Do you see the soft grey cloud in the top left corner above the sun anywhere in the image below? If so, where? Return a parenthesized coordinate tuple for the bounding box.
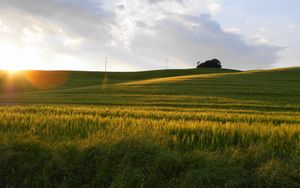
(0, 0, 114, 40)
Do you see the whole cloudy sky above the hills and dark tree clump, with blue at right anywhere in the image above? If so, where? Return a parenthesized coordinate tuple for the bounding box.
(0, 0, 300, 71)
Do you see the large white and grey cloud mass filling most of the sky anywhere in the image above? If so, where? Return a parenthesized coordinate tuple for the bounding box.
(0, 0, 281, 70)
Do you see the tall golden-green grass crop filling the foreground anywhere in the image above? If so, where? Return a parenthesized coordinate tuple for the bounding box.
(0, 105, 300, 187)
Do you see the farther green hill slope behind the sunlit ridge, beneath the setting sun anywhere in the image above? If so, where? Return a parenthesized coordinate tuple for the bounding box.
(0, 68, 238, 92)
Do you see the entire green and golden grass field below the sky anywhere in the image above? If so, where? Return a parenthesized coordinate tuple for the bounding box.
(0, 67, 300, 188)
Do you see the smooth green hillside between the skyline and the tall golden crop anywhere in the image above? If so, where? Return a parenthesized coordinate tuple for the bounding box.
(0, 67, 300, 105)
